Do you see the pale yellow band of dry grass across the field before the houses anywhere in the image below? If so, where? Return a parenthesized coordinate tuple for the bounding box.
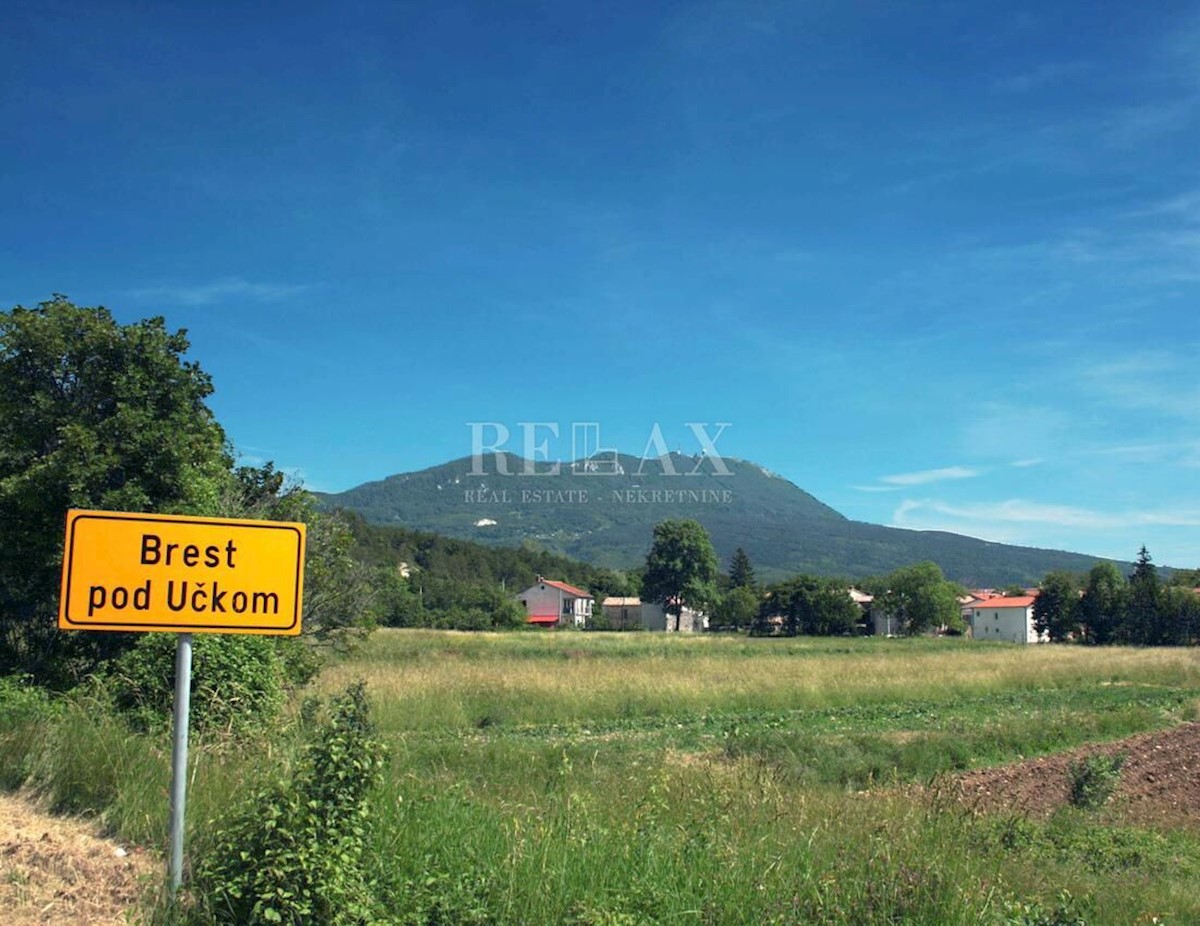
(322, 630, 1200, 730)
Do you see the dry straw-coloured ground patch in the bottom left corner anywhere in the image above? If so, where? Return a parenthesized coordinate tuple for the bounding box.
(0, 794, 161, 926)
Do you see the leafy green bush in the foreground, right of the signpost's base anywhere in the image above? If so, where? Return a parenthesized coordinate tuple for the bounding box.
(192, 683, 384, 926)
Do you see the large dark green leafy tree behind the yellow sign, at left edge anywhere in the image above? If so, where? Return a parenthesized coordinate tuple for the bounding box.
(0, 296, 232, 685)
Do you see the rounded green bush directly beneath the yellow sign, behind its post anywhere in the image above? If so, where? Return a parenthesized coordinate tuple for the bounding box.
(112, 633, 290, 732)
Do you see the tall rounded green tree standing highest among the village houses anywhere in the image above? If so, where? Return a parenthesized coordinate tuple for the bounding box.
(642, 519, 718, 631)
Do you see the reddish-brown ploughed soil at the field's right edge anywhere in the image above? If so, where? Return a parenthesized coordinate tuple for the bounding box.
(955, 723, 1200, 829)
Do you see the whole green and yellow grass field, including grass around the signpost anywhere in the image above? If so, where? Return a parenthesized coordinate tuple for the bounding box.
(7, 631, 1200, 926)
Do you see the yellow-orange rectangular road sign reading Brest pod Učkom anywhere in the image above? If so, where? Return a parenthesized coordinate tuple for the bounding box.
(59, 510, 305, 635)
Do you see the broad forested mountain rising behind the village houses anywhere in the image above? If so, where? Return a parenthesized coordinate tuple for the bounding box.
(320, 453, 1123, 587)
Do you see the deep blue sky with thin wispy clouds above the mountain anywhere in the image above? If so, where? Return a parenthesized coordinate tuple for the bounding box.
(0, 0, 1200, 566)
